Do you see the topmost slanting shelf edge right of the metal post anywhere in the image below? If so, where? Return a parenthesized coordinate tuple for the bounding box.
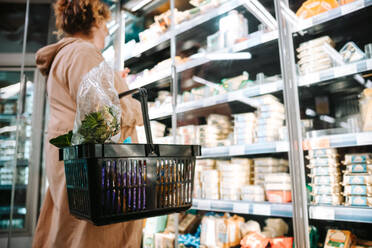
(295, 0, 372, 32)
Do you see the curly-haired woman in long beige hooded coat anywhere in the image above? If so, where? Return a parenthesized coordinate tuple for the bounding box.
(33, 0, 142, 248)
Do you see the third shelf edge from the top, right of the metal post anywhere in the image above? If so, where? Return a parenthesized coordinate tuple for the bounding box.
(303, 132, 372, 150)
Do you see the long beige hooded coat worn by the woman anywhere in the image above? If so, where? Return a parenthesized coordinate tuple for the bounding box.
(32, 38, 142, 248)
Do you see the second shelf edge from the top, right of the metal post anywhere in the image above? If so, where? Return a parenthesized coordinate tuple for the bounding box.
(299, 59, 372, 86)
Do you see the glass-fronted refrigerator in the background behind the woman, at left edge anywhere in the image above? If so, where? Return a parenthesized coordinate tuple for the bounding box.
(0, 68, 45, 235)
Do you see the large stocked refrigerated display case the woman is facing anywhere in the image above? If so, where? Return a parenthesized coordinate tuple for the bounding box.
(124, 0, 372, 247)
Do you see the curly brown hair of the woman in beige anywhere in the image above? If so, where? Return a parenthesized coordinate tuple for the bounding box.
(54, 0, 111, 36)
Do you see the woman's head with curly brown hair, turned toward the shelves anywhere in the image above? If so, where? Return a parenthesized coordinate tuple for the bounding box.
(54, 0, 110, 49)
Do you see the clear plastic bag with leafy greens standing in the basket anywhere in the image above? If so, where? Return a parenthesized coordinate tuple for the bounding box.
(72, 61, 121, 145)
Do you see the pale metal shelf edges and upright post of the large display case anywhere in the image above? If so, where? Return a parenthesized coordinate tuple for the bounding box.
(123, 0, 372, 247)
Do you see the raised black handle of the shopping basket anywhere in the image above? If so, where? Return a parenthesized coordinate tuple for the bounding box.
(119, 88, 155, 152)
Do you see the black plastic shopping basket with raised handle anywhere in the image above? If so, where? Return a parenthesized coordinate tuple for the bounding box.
(60, 88, 201, 225)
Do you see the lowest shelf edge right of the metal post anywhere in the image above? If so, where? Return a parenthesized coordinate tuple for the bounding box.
(309, 206, 372, 223)
